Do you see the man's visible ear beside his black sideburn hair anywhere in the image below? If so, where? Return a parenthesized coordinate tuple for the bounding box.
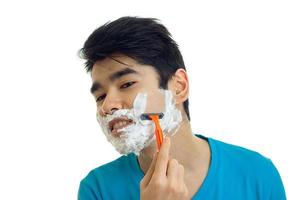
(168, 68, 189, 104)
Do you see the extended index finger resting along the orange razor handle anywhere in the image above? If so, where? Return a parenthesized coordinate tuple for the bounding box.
(153, 137, 171, 177)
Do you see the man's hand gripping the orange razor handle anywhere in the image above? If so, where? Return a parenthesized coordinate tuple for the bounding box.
(140, 137, 188, 200)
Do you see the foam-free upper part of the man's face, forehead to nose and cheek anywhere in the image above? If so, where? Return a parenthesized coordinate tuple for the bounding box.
(91, 55, 163, 116)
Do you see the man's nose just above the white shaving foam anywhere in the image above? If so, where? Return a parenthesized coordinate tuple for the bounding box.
(100, 92, 122, 116)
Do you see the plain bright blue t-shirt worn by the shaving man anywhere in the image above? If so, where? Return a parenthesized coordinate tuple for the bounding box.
(78, 135, 286, 200)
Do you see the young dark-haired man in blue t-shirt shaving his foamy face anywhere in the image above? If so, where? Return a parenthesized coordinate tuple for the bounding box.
(78, 17, 286, 200)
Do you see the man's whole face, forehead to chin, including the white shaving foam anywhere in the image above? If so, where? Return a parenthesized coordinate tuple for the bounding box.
(91, 55, 181, 154)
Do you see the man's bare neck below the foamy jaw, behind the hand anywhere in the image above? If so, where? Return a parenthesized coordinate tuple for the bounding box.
(138, 119, 210, 173)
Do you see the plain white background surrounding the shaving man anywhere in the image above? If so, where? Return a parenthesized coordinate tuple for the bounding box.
(0, 0, 300, 200)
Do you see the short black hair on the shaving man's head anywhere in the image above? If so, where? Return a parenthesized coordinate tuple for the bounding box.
(79, 17, 190, 120)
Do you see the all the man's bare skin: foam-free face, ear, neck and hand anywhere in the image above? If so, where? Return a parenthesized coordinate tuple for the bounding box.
(91, 54, 210, 200)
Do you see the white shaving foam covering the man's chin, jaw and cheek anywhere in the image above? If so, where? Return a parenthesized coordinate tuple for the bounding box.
(97, 90, 182, 155)
